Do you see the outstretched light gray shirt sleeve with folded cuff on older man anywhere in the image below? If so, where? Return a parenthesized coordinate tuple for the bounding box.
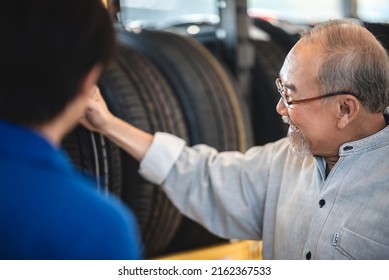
(140, 133, 278, 240)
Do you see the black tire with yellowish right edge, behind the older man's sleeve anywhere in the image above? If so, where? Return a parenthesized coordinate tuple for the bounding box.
(115, 27, 252, 253)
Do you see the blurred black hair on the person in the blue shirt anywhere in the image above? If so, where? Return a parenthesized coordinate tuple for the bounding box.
(0, 0, 114, 126)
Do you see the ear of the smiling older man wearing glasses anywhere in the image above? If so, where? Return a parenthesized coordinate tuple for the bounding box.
(337, 95, 360, 129)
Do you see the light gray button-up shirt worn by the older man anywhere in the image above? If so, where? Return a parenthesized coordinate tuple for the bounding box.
(140, 123, 389, 259)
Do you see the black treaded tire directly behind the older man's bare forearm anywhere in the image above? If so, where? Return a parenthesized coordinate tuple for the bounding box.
(100, 45, 188, 257)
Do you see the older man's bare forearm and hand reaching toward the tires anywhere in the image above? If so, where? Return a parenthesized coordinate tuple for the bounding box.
(80, 86, 153, 161)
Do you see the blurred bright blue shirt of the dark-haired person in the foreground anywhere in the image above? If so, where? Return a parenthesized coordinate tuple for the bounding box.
(0, 121, 141, 260)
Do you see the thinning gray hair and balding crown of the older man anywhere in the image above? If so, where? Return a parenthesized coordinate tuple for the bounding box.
(301, 20, 389, 113)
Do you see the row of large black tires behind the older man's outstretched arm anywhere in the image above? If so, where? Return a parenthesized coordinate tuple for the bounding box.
(63, 24, 253, 258)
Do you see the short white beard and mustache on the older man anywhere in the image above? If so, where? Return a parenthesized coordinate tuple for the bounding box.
(282, 116, 312, 157)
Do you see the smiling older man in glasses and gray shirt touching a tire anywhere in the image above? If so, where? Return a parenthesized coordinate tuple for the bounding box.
(83, 20, 389, 259)
